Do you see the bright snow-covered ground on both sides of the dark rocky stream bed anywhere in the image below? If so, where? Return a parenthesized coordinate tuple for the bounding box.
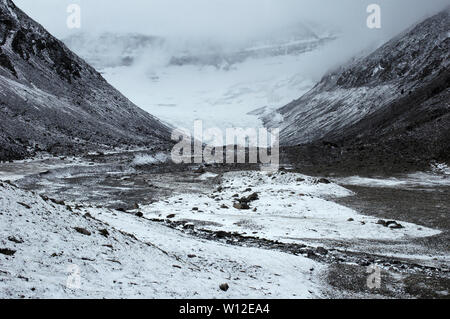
(0, 171, 439, 298)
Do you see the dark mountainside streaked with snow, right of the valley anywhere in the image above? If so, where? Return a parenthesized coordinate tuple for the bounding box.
(265, 9, 450, 159)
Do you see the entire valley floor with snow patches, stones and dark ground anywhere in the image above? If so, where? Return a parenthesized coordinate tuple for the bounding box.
(0, 152, 450, 298)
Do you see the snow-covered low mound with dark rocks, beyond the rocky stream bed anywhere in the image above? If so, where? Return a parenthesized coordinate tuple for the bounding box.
(142, 171, 440, 243)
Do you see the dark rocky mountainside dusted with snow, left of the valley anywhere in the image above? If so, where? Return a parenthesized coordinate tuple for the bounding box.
(0, 0, 169, 160)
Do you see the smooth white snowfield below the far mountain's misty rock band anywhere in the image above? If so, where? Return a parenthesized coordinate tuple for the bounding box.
(102, 55, 314, 131)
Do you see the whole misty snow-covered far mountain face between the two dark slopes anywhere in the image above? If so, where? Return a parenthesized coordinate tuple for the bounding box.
(63, 25, 334, 130)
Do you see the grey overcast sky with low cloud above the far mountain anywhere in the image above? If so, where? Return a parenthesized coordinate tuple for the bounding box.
(13, 0, 450, 38)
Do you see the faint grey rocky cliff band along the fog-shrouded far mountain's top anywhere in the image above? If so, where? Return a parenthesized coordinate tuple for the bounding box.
(62, 23, 330, 71)
